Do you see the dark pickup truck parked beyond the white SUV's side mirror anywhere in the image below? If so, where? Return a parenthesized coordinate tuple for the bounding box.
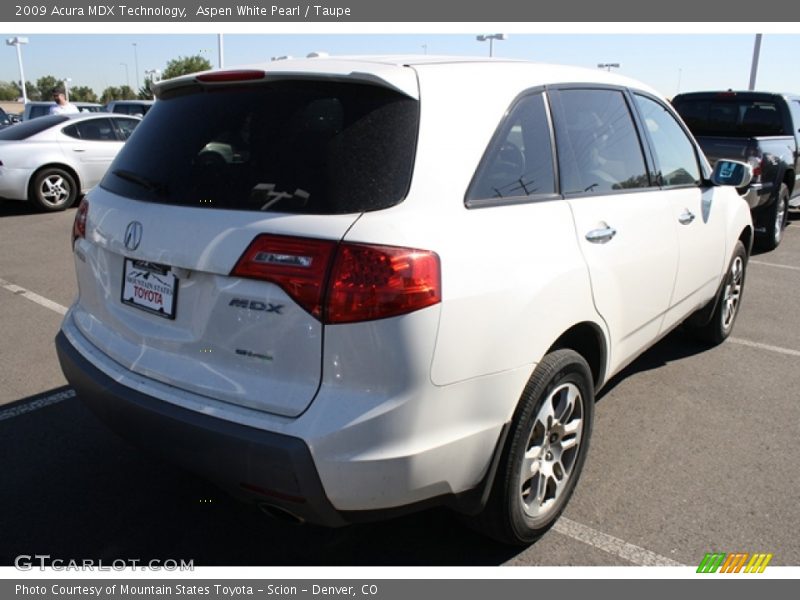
(672, 91, 800, 250)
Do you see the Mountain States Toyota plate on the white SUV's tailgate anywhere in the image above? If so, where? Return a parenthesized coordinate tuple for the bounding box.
(122, 258, 178, 319)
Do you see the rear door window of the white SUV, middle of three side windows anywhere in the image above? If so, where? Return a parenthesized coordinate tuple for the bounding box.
(557, 90, 650, 193)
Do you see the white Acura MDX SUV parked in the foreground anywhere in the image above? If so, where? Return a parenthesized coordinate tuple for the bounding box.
(56, 57, 753, 544)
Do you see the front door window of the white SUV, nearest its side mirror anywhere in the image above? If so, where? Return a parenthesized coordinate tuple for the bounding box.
(634, 94, 700, 187)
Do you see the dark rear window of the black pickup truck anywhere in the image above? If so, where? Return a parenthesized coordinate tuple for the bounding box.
(675, 97, 788, 137)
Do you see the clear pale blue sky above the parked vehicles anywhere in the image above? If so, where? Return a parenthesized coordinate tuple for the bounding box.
(0, 30, 800, 97)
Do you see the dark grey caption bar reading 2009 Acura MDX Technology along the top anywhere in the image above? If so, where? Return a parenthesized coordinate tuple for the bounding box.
(0, 0, 800, 25)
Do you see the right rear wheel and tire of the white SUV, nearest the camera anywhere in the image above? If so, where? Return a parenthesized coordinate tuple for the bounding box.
(475, 350, 594, 546)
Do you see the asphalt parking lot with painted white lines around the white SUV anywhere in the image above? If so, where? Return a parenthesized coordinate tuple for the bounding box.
(0, 202, 800, 566)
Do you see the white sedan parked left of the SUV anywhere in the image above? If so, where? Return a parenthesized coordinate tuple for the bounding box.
(0, 113, 141, 211)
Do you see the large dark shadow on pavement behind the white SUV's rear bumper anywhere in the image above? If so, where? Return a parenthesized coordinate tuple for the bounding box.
(0, 388, 519, 566)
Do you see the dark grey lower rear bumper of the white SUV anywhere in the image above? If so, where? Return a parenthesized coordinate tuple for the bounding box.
(55, 332, 348, 527)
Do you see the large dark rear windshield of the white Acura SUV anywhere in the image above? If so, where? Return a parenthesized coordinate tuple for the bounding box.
(101, 81, 419, 214)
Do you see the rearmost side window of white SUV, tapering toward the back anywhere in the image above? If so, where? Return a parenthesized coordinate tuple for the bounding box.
(467, 94, 556, 201)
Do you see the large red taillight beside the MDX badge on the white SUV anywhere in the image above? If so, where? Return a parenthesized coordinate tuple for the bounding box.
(231, 235, 441, 324)
